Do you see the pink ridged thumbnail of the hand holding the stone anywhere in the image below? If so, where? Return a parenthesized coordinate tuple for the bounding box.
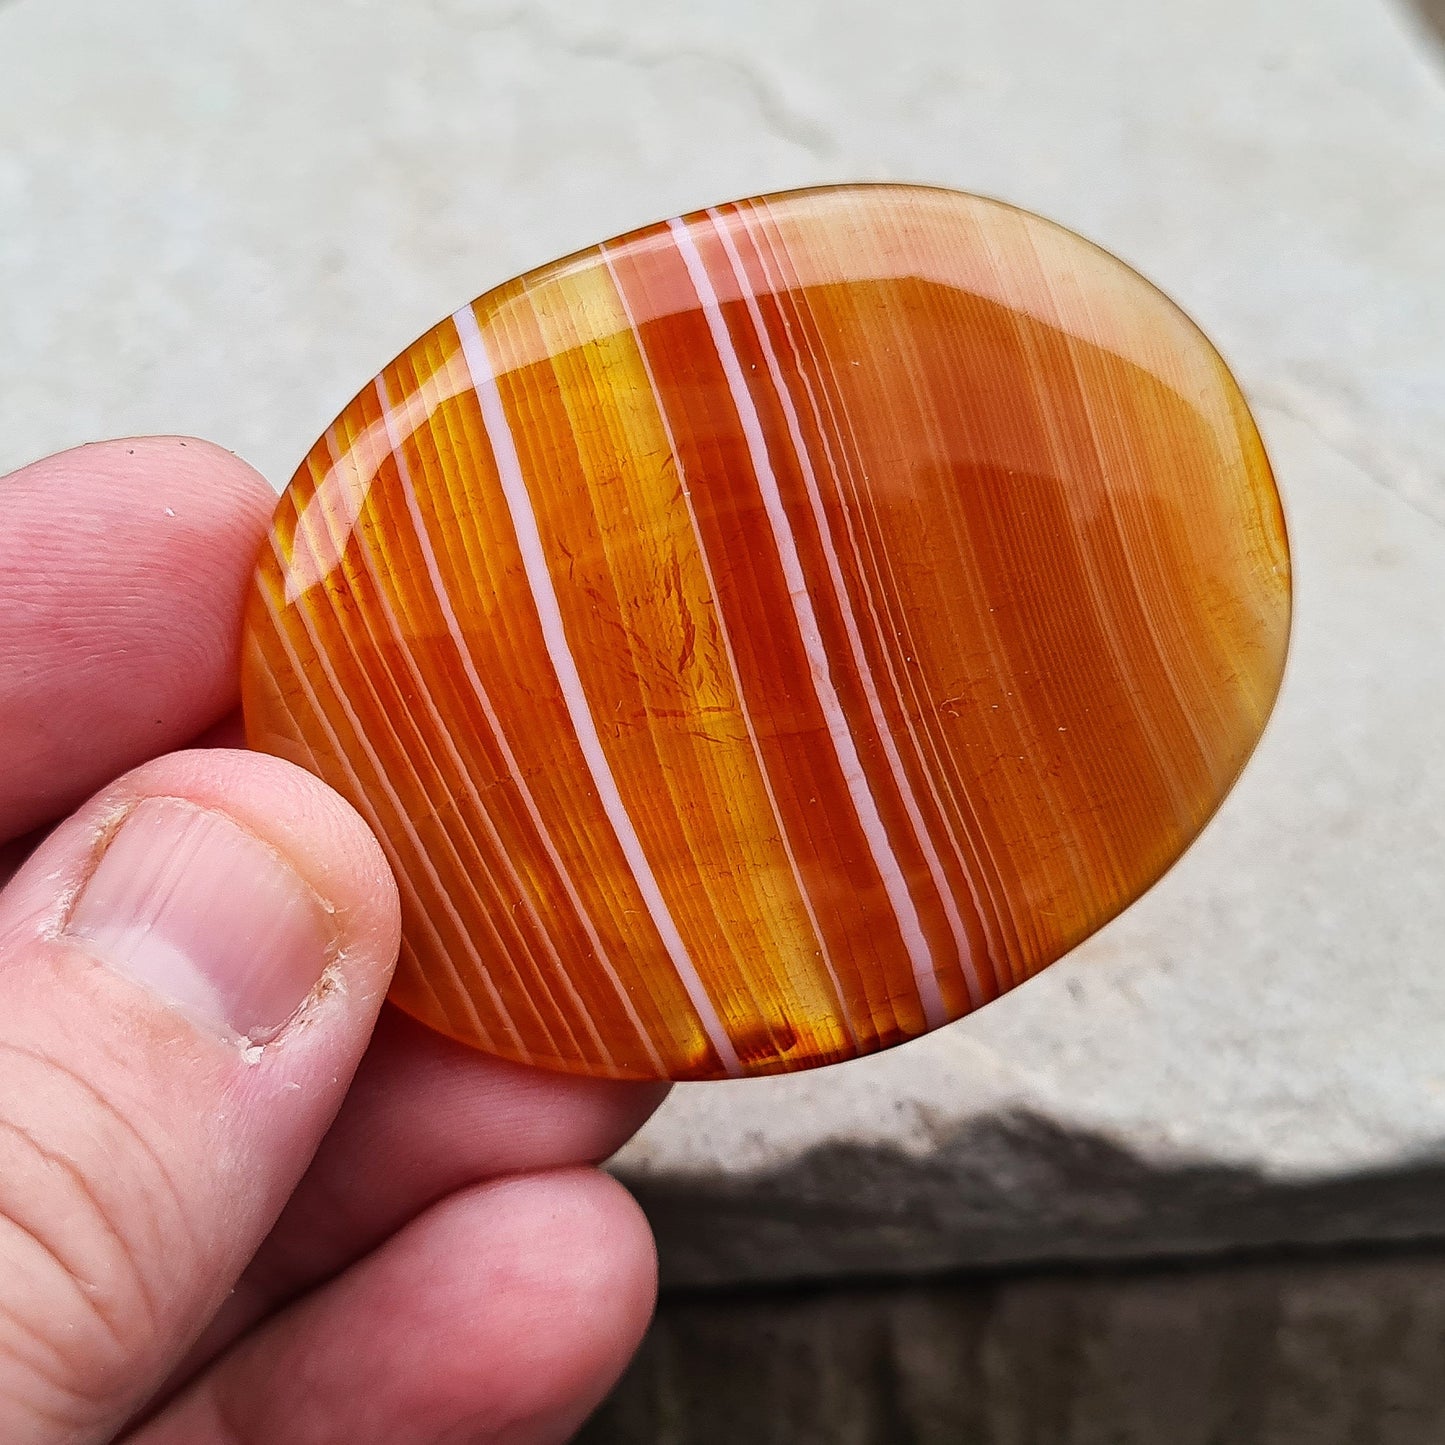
(65, 798, 335, 1040)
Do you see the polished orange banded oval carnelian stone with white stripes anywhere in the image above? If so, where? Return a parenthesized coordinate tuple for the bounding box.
(244, 185, 1289, 1079)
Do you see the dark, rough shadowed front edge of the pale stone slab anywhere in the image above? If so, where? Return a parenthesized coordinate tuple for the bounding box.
(624, 1113, 1445, 1287)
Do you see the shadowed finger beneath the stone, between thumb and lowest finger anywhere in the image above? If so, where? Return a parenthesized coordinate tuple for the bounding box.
(183, 1009, 666, 1364)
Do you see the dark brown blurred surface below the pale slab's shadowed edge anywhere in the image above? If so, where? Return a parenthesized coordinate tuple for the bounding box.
(579, 1248, 1445, 1445)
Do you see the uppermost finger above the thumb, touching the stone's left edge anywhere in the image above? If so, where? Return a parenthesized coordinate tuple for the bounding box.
(0, 436, 276, 841)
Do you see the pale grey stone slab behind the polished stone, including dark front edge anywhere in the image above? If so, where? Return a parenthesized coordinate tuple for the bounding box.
(0, 0, 1445, 1282)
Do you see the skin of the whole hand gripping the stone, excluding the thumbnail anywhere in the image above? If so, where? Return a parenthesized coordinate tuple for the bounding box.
(0, 438, 663, 1445)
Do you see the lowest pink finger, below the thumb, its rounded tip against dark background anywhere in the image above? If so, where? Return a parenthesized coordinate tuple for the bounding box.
(133, 1170, 656, 1445)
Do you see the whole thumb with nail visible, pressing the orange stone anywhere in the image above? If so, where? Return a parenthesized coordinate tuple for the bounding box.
(0, 750, 399, 1445)
